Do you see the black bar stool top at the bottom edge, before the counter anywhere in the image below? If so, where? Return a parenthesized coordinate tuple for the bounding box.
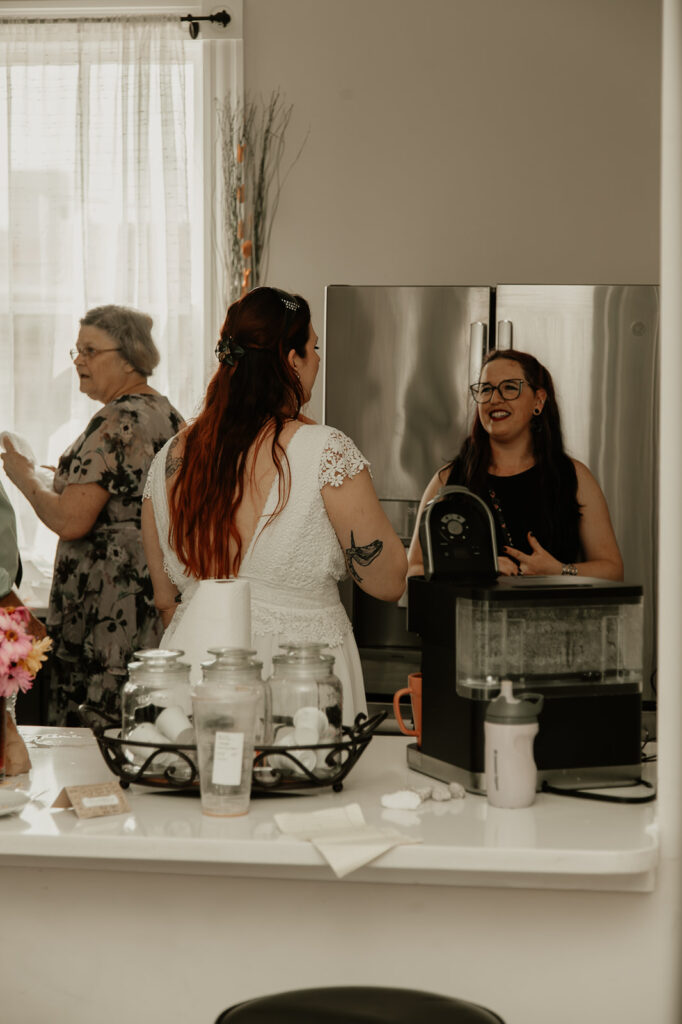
(215, 985, 504, 1024)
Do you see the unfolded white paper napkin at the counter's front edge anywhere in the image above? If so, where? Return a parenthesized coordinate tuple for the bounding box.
(274, 804, 421, 879)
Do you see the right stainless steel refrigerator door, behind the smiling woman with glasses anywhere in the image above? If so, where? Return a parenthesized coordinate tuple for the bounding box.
(496, 285, 659, 696)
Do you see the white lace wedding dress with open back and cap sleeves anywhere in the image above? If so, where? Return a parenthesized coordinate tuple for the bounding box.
(144, 424, 369, 725)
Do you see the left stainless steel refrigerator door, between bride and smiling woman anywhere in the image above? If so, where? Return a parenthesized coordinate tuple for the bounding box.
(325, 285, 491, 503)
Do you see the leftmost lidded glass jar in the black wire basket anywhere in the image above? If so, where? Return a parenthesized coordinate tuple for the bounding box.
(121, 648, 195, 770)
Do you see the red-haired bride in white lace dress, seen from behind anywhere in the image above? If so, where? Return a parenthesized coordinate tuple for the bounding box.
(142, 288, 407, 724)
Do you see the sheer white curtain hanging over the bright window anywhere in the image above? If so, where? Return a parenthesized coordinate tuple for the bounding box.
(0, 16, 205, 581)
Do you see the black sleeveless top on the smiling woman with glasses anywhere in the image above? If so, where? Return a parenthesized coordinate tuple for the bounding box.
(447, 459, 580, 562)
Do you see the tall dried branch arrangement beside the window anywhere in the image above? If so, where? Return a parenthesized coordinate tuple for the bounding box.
(216, 89, 307, 302)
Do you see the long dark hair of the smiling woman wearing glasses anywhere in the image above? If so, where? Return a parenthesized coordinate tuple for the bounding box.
(451, 348, 581, 558)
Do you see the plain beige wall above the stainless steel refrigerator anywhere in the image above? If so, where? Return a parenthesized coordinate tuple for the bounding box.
(244, 0, 660, 415)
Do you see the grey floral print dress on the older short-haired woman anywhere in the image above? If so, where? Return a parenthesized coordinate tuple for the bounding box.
(47, 394, 183, 725)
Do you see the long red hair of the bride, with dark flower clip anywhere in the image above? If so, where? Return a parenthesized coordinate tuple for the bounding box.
(169, 288, 310, 580)
